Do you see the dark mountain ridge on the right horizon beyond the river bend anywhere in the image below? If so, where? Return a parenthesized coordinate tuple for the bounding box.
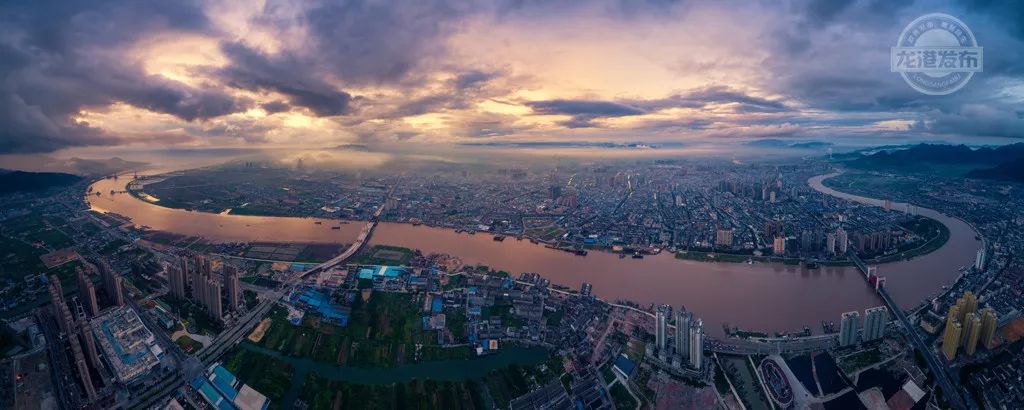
(846, 142, 1024, 181)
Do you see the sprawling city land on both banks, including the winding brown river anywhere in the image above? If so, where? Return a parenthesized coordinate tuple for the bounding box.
(2, 151, 1024, 408)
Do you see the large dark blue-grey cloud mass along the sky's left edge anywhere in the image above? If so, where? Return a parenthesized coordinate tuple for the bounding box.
(0, 0, 246, 153)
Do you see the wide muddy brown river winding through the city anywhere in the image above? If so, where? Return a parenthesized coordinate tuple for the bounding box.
(89, 174, 980, 335)
